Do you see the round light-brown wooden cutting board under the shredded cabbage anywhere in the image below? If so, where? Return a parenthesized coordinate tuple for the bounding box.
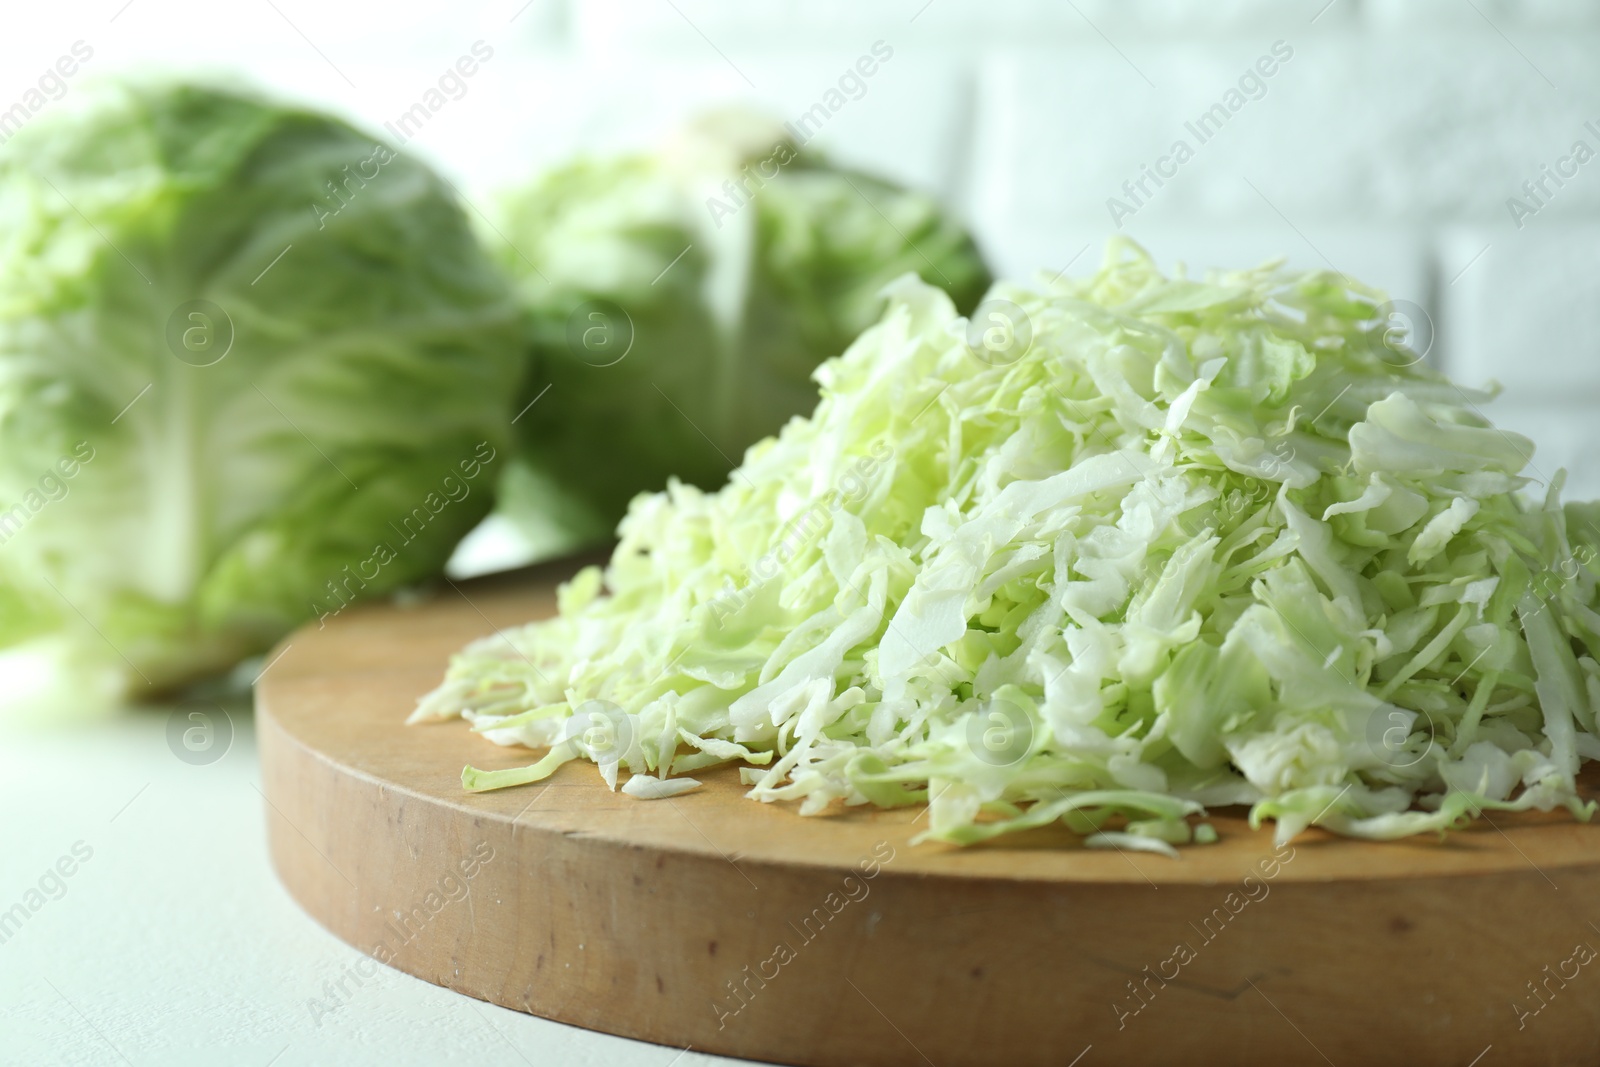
(256, 565, 1600, 1067)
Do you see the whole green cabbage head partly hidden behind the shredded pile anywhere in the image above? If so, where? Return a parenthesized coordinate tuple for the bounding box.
(499, 110, 990, 555)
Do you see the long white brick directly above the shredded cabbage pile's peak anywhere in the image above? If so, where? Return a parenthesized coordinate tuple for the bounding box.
(978, 35, 1600, 227)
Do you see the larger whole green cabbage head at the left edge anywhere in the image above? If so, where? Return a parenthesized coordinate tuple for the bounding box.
(0, 83, 523, 710)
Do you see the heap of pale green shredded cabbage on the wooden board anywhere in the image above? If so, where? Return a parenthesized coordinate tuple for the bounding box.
(413, 242, 1600, 853)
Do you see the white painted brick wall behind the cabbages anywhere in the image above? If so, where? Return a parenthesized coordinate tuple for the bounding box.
(0, 0, 1600, 494)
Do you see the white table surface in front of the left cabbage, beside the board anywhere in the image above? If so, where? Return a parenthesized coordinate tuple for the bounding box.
(0, 704, 741, 1067)
